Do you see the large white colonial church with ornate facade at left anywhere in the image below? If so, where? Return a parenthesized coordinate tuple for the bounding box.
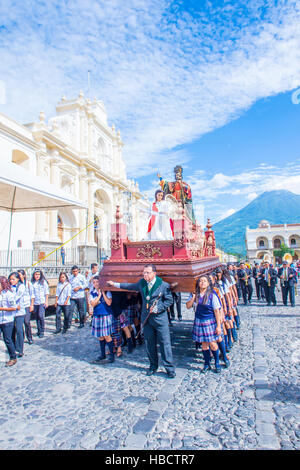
(0, 92, 149, 266)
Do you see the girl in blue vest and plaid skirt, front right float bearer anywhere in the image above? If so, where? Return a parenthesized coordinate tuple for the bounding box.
(186, 275, 221, 374)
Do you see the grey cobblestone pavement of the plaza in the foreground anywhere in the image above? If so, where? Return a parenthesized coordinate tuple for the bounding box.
(0, 294, 300, 450)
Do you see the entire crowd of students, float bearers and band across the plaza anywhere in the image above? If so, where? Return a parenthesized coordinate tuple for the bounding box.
(0, 261, 300, 378)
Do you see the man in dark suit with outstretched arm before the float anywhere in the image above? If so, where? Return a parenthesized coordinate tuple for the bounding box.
(107, 264, 176, 378)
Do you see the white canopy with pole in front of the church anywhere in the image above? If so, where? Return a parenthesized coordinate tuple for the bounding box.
(0, 162, 87, 264)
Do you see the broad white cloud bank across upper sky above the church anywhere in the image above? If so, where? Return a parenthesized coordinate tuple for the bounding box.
(0, 0, 300, 178)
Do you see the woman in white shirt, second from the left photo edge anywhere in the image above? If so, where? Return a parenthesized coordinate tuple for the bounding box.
(8, 272, 26, 357)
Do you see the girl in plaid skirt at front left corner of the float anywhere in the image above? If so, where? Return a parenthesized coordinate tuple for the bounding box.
(90, 276, 115, 363)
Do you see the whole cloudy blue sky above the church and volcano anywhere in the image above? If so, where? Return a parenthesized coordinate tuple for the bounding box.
(0, 0, 300, 222)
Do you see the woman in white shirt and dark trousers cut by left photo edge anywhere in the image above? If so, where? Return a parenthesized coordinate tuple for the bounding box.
(0, 276, 18, 367)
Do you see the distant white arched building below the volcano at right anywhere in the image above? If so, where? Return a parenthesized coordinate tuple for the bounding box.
(246, 220, 300, 263)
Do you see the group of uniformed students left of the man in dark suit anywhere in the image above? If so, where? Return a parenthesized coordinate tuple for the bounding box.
(0, 263, 143, 367)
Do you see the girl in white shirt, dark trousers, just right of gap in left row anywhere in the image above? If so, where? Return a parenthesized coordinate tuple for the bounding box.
(54, 271, 72, 334)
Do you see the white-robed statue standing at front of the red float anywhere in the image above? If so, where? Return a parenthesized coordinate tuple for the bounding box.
(144, 189, 174, 240)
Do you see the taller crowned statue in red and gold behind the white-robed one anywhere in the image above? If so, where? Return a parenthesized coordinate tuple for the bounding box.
(157, 165, 196, 224)
